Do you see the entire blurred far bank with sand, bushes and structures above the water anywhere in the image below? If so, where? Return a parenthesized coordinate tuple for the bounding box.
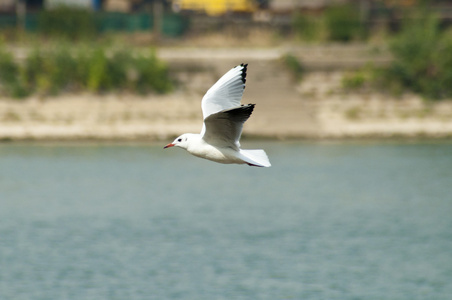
(0, 0, 452, 140)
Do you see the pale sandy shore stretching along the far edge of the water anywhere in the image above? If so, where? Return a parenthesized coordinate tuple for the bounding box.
(0, 50, 452, 141)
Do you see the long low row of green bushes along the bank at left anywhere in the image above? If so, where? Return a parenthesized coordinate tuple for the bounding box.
(0, 46, 172, 98)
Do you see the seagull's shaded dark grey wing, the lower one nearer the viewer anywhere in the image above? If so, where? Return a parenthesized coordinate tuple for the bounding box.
(202, 104, 255, 148)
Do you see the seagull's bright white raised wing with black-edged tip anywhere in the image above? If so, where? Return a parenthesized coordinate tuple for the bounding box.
(201, 64, 248, 119)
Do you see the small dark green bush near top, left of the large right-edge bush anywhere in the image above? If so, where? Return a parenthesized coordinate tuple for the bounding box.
(324, 4, 366, 42)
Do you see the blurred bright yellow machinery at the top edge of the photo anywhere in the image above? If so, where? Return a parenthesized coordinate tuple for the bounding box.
(173, 0, 257, 16)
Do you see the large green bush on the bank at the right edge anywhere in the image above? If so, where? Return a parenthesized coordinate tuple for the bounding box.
(380, 12, 452, 99)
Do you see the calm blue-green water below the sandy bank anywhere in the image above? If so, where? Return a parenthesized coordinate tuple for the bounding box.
(0, 143, 452, 300)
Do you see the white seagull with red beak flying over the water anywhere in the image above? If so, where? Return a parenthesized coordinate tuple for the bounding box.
(164, 64, 271, 167)
